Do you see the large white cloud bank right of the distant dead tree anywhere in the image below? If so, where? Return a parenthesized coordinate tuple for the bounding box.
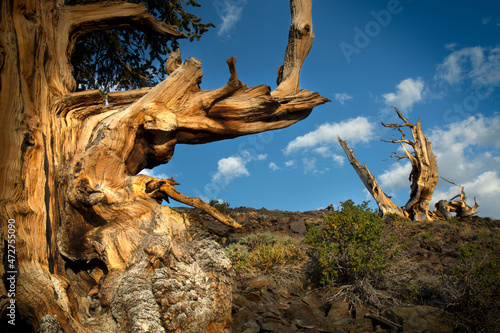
(429, 114, 500, 218)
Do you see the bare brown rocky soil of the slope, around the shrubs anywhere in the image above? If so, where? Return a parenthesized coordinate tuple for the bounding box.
(175, 207, 500, 333)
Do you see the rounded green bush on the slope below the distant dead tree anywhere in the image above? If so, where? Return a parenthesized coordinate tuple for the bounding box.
(305, 200, 393, 285)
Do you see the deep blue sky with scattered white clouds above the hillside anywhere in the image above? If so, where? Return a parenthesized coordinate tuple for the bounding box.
(140, 0, 500, 218)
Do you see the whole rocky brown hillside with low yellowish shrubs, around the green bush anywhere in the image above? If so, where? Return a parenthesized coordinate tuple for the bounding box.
(176, 207, 500, 332)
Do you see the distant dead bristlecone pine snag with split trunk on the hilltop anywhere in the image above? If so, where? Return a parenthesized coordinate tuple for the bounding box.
(338, 108, 479, 221)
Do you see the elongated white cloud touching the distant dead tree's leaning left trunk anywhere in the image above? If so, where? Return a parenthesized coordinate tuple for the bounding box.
(284, 117, 374, 155)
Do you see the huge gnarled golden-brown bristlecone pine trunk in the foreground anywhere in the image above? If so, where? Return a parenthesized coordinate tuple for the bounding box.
(0, 0, 327, 332)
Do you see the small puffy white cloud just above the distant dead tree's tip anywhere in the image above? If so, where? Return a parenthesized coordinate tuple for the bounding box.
(382, 78, 425, 111)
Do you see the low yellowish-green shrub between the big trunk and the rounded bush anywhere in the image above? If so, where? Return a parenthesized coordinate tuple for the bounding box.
(223, 232, 307, 272)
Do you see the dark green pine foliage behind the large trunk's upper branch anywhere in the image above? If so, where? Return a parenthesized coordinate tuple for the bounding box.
(65, 0, 214, 92)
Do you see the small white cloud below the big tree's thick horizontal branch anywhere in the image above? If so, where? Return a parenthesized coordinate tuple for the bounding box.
(212, 151, 267, 186)
